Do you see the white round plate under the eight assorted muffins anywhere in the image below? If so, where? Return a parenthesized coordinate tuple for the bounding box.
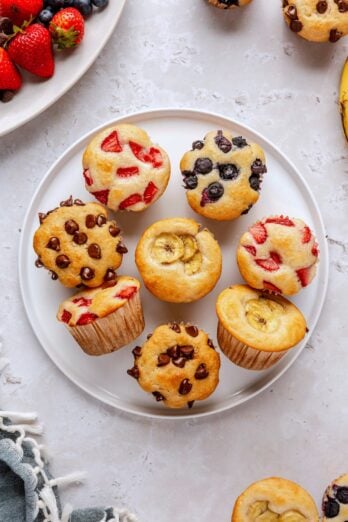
(19, 109, 328, 418)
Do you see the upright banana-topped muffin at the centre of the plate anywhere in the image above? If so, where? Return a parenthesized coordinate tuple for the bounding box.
(135, 218, 222, 303)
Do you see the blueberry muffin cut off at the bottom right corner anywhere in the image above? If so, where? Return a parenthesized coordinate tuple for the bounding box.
(323, 475, 348, 522)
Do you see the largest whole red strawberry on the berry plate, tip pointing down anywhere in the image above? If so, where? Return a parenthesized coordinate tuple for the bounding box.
(8, 24, 54, 78)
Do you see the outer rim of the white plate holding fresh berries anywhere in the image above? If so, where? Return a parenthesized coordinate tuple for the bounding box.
(0, 0, 127, 138)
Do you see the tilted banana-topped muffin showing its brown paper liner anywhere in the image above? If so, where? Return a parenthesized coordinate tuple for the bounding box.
(216, 285, 307, 370)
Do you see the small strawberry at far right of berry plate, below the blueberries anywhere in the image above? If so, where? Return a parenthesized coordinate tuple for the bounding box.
(49, 7, 85, 49)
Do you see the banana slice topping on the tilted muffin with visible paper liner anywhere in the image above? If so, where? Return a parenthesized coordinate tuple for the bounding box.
(245, 297, 283, 333)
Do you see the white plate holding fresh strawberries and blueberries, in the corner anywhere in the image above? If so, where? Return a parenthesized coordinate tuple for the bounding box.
(0, 0, 126, 136)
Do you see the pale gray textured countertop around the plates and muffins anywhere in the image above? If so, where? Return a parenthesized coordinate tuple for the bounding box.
(0, 0, 348, 522)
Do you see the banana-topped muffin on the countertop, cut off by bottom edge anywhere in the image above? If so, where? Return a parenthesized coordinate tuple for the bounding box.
(232, 477, 319, 522)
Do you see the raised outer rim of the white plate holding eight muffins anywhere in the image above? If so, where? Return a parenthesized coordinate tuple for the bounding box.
(18, 107, 330, 420)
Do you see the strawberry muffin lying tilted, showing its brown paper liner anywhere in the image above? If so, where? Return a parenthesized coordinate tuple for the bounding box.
(57, 276, 145, 355)
